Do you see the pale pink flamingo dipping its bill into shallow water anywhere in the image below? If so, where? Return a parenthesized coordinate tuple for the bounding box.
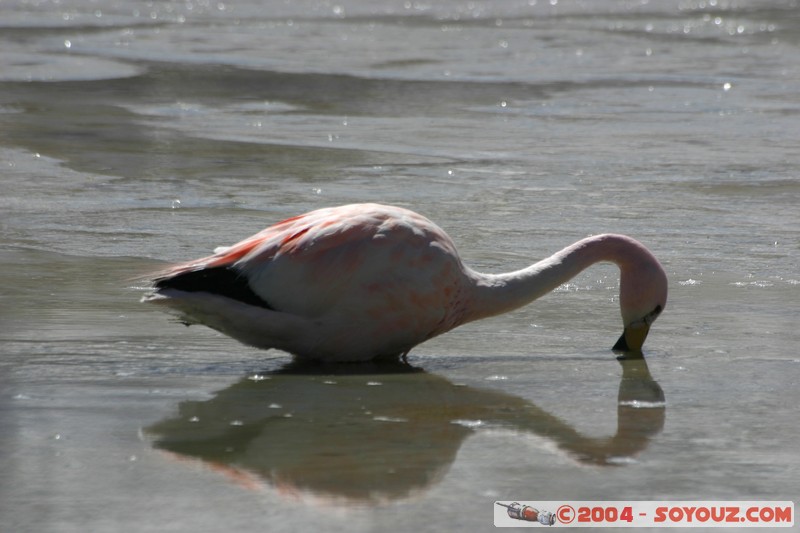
(143, 204, 667, 362)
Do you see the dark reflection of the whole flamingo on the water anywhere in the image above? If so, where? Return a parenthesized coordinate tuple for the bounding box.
(147, 359, 665, 503)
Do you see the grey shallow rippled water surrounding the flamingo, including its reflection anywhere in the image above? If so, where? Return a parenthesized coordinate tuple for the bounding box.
(0, 0, 800, 532)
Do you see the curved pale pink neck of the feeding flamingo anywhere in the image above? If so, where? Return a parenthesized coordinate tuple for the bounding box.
(465, 234, 663, 322)
